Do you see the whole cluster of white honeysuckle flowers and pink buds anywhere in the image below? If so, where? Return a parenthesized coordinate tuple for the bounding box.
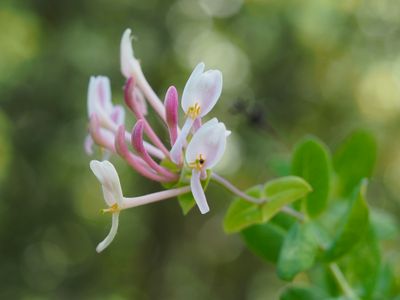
(85, 29, 230, 252)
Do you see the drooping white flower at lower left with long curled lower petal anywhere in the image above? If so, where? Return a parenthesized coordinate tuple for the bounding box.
(90, 160, 124, 252)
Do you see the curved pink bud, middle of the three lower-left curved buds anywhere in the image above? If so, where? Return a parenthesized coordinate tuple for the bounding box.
(115, 125, 172, 182)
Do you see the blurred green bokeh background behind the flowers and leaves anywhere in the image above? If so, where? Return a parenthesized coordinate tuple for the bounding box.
(0, 0, 400, 300)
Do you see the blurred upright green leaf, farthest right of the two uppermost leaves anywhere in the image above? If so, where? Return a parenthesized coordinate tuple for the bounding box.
(333, 131, 377, 195)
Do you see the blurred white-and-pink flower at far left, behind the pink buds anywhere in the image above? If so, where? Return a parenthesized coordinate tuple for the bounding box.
(85, 76, 125, 154)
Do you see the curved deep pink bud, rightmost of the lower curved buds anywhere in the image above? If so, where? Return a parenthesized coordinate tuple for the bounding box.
(131, 120, 178, 180)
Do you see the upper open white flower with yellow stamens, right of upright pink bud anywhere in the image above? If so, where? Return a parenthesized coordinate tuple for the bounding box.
(171, 63, 222, 164)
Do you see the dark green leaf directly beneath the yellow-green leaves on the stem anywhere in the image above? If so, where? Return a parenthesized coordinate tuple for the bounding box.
(241, 221, 287, 262)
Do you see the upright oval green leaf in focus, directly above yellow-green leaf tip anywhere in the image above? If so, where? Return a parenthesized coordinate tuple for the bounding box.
(292, 137, 331, 217)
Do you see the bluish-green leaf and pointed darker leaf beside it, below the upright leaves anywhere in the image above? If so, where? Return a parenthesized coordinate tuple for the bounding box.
(277, 181, 369, 280)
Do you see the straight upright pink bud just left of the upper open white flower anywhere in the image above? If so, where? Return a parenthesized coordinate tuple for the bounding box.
(164, 86, 179, 146)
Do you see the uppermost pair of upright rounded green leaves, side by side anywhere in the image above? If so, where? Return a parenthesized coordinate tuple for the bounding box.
(292, 131, 377, 218)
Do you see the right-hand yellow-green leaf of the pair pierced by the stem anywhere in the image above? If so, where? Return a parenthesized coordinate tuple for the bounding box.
(263, 176, 312, 222)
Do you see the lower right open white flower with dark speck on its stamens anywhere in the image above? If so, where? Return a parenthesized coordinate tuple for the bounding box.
(185, 118, 230, 214)
